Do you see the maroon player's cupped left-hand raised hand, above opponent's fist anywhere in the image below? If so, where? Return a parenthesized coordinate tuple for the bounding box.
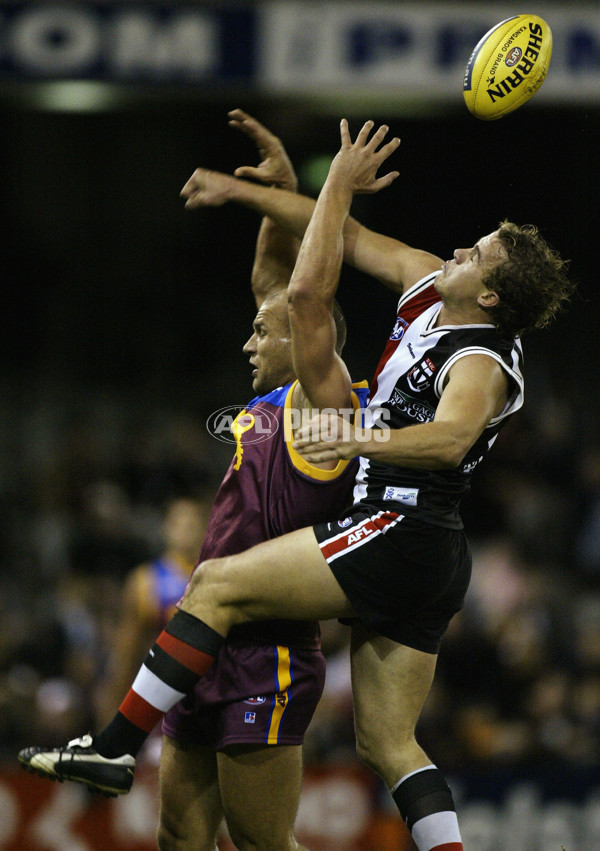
(229, 109, 298, 192)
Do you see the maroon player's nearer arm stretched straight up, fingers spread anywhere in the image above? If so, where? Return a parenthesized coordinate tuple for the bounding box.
(288, 119, 400, 408)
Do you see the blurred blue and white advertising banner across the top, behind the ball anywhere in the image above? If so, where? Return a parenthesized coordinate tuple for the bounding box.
(0, 0, 600, 104)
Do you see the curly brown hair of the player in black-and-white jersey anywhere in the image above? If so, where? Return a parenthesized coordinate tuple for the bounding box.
(483, 221, 575, 337)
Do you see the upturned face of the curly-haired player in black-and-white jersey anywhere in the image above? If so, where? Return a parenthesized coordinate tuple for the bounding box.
(435, 231, 507, 303)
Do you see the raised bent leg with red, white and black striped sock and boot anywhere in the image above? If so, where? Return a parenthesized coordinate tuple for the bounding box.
(19, 528, 354, 794)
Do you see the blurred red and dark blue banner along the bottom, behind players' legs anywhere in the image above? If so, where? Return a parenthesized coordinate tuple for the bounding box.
(0, 763, 600, 851)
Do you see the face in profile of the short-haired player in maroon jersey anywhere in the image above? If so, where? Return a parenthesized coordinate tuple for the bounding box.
(243, 296, 295, 396)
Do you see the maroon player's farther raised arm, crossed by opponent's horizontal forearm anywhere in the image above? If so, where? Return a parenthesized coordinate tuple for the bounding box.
(229, 109, 300, 307)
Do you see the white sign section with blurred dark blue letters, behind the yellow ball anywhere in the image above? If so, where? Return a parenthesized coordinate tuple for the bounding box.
(259, 0, 600, 103)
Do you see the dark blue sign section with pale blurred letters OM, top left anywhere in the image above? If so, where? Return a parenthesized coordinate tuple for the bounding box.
(0, 2, 255, 84)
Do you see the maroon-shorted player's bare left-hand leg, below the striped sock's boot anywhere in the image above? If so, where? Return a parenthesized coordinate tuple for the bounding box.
(157, 736, 223, 851)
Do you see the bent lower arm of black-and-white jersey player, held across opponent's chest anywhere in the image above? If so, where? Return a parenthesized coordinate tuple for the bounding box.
(294, 354, 508, 470)
